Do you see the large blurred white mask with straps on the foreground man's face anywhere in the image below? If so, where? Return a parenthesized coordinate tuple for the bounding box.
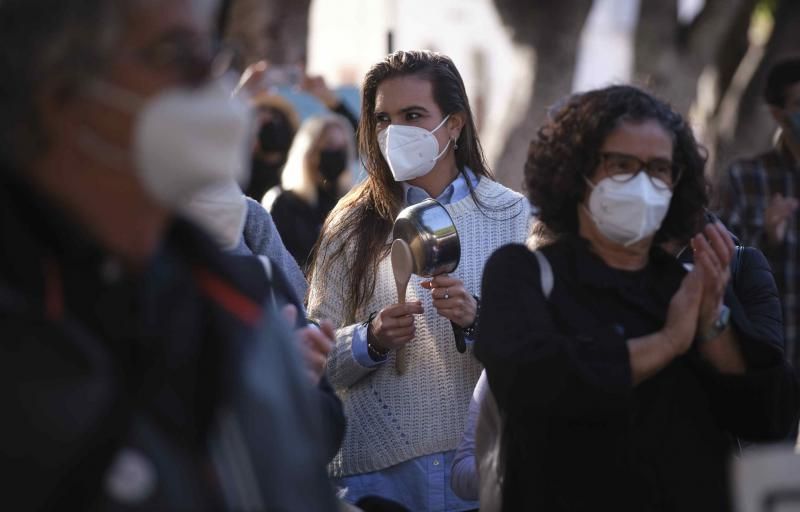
(84, 77, 254, 208)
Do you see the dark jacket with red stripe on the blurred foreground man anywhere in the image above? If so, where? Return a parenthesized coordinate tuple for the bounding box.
(0, 171, 335, 511)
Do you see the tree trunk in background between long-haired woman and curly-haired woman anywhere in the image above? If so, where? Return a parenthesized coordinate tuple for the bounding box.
(494, 0, 592, 190)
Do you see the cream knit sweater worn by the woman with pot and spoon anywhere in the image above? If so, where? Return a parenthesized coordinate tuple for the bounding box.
(308, 178, 530, 477)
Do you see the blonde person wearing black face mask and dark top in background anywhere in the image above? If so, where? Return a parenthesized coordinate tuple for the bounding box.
(263, 114, 355, 268)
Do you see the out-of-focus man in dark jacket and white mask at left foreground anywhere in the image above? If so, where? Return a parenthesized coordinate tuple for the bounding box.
(0, 0, 335, 510)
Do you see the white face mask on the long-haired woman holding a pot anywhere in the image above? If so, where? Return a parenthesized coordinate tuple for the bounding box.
(378, 115, 451, 181)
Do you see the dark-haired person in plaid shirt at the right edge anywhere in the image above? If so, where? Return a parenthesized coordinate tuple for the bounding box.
(722, 57, 800, 368)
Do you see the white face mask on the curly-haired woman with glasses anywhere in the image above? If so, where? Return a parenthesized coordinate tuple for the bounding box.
(586, 172, 672, 246)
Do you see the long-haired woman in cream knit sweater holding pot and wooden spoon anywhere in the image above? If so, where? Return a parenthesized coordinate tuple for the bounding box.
(308, 51, 530, 511)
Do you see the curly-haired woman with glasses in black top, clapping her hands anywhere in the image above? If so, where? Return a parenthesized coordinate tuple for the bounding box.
(475, 86, 798, 511)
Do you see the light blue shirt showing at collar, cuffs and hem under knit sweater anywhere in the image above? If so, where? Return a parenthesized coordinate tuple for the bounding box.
(337, 169, 479, 512)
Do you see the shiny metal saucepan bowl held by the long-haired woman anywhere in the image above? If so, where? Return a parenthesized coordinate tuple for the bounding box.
(392, 199, 461, 277)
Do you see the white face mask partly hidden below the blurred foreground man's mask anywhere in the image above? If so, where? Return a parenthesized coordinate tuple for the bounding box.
(179, 180, 247, 250)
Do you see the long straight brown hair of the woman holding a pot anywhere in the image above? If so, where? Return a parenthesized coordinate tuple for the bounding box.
(310, 51, 492, 323)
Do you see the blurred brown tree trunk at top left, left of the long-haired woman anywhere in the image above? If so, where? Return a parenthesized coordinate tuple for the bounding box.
(225, 0, 311, 66)
